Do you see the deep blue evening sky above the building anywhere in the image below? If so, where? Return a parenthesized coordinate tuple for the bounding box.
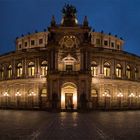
(0, 0, 140, 56)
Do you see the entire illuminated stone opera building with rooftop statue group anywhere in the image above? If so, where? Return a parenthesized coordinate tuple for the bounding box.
(0, 5, 140, 109)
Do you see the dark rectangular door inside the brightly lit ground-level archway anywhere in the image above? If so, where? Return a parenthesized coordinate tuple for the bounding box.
(65, 93, 73, 109)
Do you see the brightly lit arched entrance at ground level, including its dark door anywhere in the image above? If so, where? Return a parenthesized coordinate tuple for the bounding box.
(61, 82, 77, 109)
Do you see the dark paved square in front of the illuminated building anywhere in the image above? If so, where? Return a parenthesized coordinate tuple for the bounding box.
(0, 110, 140, 140)
